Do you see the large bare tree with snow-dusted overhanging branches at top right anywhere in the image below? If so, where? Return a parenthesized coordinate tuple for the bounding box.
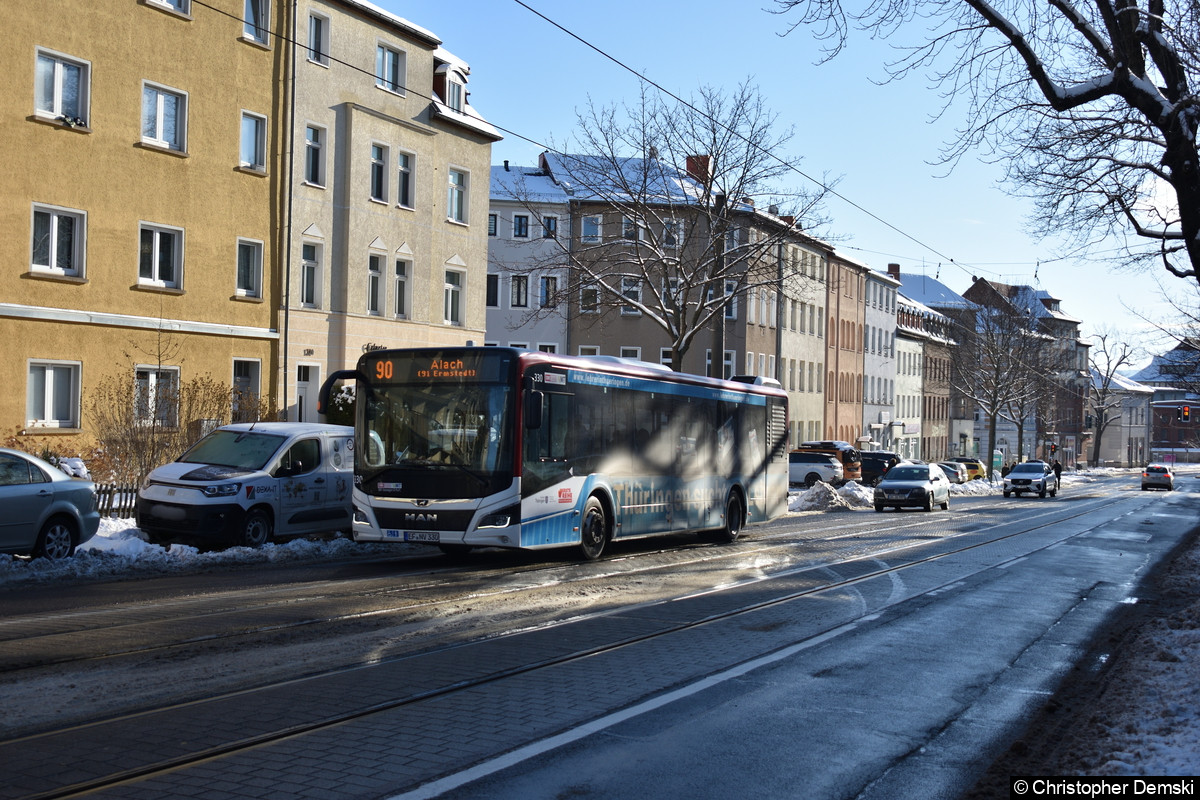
(775, 0, 1200, 282)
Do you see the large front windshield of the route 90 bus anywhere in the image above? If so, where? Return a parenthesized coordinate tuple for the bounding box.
(356, 381, 512, 497)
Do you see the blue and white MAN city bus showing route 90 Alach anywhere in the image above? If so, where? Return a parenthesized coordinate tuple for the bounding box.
(319, 347, 787, 560)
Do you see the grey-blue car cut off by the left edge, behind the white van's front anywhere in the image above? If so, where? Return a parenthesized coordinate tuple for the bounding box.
(0, 447, 100, 560)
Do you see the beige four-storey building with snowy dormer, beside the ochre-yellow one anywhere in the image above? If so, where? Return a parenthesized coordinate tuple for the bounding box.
(280, 0, 500, 420)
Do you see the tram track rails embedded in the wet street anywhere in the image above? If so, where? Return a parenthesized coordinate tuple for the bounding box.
(0, 489, 1147, 800)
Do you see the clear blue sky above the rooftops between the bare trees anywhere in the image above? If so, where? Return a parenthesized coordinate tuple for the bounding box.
(373, 0, 1176, 350)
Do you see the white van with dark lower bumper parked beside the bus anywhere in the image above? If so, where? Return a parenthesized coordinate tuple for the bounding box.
(137, 422, 354, 547)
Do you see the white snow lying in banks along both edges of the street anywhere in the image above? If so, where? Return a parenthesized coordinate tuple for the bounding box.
(0, 469, 1200, 775)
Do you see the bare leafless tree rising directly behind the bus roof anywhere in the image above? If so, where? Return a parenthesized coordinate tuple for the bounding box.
(500, 85, 827, 368)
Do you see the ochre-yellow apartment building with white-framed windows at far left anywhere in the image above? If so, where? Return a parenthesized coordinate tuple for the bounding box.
(0, 0, 289, 451)
